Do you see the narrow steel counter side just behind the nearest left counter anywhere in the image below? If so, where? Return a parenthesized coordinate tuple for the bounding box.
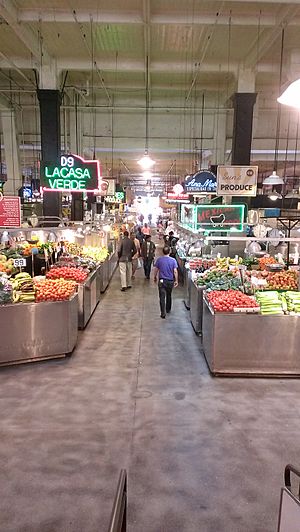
(78, 270, 99, 329)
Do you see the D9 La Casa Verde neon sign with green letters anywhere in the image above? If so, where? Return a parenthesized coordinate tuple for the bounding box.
(41, 155, 102, 192)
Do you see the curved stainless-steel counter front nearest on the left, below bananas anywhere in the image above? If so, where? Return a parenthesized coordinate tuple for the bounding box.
(0, 294, 78, 365)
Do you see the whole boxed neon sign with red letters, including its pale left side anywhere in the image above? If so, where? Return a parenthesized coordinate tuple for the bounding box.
(180, 203, 245, 232)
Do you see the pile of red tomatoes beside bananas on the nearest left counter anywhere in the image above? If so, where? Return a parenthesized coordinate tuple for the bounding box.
(35, 279, 76, 303)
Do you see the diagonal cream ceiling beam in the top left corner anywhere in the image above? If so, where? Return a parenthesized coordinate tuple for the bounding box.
(0, 0, 50, 64)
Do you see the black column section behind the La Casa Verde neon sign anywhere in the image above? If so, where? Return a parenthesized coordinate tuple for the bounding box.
(37, 89, 61, 216)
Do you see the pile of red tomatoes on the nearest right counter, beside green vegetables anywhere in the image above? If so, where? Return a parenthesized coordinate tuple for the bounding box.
(206, 290, 259, 312)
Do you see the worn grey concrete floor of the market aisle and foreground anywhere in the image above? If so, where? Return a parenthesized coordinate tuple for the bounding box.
(0, 272, 300, 532)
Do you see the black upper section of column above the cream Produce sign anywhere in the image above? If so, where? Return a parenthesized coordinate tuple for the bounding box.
(231, 92, 257, 166)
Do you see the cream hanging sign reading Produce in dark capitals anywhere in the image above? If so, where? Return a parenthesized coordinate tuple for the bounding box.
(217, 166, 258, 196)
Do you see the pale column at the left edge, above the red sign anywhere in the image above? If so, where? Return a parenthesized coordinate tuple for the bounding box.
(1, 109, 22, 196)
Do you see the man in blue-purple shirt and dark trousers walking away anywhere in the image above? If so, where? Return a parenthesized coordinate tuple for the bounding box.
(154, 246, 178, 319)
